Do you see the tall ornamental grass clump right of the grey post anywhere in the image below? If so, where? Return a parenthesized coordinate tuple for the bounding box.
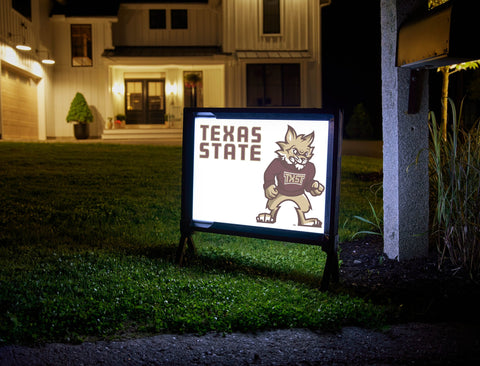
(429, 101, 480, 278)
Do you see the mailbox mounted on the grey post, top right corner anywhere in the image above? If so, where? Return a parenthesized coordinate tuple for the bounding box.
(397, 0, 480, 69)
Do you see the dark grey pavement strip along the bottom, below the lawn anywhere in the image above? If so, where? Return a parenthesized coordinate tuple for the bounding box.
(0, 323, 480, 366)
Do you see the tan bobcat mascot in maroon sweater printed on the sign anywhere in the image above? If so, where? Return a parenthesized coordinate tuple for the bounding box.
(257, 126, 325, 227)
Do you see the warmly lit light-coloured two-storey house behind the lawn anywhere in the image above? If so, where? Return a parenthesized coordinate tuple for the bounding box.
(0, 0, 330, 140)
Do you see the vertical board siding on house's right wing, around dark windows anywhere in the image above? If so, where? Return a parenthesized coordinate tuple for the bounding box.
(223, 0, 322, 108)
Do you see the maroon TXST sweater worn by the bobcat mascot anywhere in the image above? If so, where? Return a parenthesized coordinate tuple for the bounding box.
(263, 158, 315, 196)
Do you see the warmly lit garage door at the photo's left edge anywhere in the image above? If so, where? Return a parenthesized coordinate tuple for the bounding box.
(0, 64, 38, 140)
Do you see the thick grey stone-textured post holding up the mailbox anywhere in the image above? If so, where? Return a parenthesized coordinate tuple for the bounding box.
(380, 0, 429, 261)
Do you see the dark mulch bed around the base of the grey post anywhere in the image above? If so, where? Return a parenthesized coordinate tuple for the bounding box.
(339, 236, 480, 323)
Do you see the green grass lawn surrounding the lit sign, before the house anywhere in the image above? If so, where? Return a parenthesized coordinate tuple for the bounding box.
(0, 142, 385, 343)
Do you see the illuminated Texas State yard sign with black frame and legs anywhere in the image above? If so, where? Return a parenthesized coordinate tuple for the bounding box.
(178, 108, 342, 286)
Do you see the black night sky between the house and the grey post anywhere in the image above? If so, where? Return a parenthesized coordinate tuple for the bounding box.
(322, 0, 382, 138)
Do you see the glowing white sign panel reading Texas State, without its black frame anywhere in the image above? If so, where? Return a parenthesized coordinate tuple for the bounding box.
(192, 116, 330, 234)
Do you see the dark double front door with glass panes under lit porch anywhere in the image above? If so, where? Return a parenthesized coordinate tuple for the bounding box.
(125, 79, 165, 124)
